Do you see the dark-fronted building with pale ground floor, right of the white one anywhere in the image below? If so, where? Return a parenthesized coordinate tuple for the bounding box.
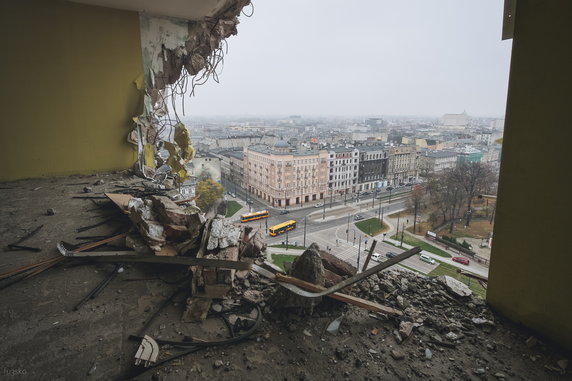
(358, 145, 388, 191)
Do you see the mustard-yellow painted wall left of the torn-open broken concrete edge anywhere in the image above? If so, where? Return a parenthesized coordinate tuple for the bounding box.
(0, 0, 143, 180)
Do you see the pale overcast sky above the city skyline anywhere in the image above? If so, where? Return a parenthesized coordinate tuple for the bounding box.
(185, 0, 511, 117)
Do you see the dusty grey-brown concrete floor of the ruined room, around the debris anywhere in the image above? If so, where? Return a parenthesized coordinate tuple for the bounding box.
(0, 173, 572, 380)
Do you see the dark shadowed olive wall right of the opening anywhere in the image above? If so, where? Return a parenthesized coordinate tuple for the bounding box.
(487, 0, 572, 349)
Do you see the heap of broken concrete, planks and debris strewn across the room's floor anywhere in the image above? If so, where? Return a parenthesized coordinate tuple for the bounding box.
(0, 174, 571, 381)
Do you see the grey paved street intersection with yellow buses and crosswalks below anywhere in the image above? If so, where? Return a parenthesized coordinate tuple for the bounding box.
(226, 180, 488, 277)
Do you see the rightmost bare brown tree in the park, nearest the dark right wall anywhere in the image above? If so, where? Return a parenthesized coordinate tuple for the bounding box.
(452, 162, 493, 226)
